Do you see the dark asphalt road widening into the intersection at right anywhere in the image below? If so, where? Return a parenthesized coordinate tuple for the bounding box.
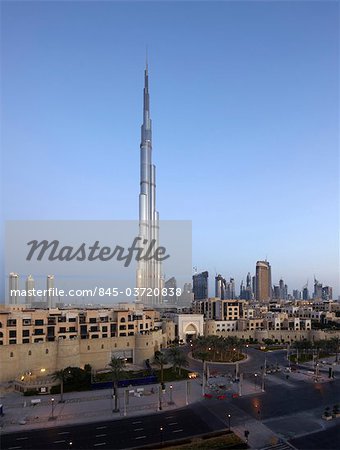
(1, 349, 340, 450)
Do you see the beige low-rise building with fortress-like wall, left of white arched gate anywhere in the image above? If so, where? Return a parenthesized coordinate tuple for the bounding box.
(0, 304, 167, 382)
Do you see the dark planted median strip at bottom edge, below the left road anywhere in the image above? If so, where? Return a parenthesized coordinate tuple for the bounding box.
(134, 430, 249, 450)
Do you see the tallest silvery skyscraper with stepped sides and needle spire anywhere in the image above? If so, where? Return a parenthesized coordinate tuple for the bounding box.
(136, 63, 163, 305)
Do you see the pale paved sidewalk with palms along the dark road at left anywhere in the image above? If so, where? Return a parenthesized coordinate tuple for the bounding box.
(0, 379, 202, 433)
